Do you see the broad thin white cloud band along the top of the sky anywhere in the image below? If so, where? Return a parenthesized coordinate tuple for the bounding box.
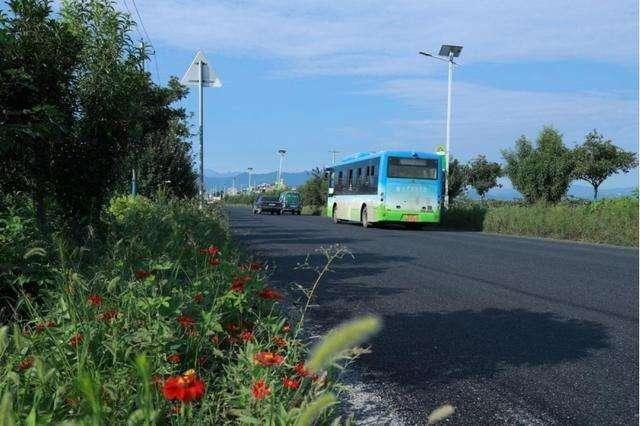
(132, 0, 637, 75)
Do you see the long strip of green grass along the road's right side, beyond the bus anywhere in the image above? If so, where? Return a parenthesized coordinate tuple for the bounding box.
(443, 197, 638, 246)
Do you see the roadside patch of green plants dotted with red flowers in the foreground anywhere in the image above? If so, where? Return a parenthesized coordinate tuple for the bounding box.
(0, 197, 362, 424)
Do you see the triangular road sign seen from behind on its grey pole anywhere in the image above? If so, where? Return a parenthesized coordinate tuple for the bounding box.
(180, 51, 222, 199)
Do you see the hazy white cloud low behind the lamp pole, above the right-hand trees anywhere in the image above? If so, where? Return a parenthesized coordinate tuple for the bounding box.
(363, 79, 638, 159)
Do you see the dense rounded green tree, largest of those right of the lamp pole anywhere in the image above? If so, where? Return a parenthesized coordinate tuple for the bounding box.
(502, 126, 575, 203)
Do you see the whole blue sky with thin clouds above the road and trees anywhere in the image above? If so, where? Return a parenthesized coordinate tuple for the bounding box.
(50, 0, 638, 187)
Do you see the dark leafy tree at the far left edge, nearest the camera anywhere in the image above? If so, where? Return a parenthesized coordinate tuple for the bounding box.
(0, 0, 80, 226)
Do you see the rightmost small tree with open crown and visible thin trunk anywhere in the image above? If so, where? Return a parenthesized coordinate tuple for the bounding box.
(573, 130, 638, 200)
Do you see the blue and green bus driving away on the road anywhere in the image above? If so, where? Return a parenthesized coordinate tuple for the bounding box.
(327, 151, 444, 228)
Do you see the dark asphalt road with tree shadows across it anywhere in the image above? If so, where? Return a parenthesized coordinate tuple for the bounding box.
(230, 209, 638, 425)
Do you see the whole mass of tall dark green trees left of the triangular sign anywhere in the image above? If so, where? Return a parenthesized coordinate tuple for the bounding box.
(0, 0, 195, 236)
